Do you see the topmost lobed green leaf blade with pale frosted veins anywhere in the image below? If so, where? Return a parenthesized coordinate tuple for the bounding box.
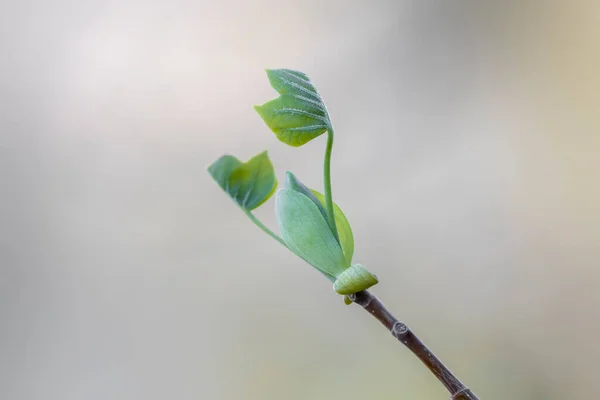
(254, 69, 331, 147)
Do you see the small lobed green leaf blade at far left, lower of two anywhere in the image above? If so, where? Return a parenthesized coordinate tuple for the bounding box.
(208, 151, 277, 211)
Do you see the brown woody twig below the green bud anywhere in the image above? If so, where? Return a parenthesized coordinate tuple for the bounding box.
(348, 290, 479, 400)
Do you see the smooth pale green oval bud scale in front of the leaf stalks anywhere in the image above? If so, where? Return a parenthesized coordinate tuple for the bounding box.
(275, 188, 350, 280)
